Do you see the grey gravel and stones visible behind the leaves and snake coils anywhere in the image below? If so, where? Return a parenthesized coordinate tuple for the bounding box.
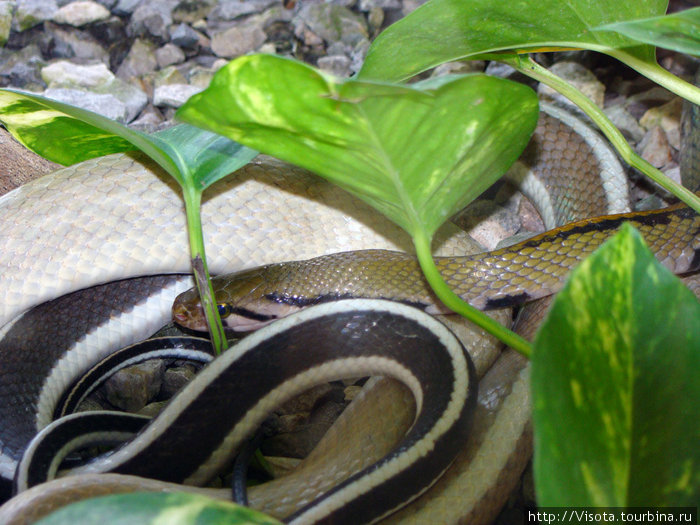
(0, 0, 697, 523)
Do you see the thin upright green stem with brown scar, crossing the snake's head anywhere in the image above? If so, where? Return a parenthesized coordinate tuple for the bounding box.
(183, 187, 228, 355)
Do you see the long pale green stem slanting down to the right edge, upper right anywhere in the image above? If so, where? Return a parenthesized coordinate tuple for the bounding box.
(499, 55, 700, 213)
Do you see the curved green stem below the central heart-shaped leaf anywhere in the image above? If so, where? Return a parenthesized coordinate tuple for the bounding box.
(413, 230, 532, 358)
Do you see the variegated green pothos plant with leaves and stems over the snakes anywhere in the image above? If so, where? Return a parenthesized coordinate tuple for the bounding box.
(0, 0, 700, 519)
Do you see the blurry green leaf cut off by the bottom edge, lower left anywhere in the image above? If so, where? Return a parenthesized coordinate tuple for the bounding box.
(37, 492, 280, 525)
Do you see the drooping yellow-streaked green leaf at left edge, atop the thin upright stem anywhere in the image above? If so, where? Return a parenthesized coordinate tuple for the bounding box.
(0, 89, 257, 188)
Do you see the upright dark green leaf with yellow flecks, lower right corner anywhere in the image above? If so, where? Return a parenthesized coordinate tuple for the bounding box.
(532, 225, 700, 507)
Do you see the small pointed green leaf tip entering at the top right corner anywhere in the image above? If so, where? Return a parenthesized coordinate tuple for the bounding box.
(596, 7, 700, 55)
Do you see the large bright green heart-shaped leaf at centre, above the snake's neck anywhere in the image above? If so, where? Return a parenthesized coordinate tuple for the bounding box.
(177, 55, 538, 235)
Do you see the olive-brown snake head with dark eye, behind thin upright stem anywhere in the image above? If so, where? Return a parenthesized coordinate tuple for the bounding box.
(172, 265, 299, 332)
